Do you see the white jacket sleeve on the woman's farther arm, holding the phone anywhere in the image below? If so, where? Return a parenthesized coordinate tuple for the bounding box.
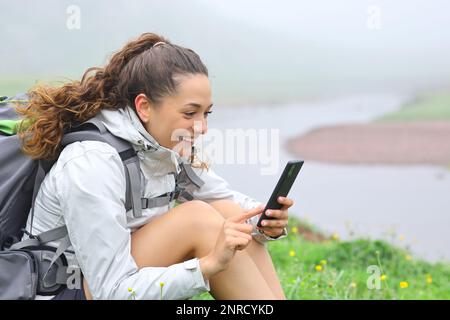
(192, 168, 287, 244)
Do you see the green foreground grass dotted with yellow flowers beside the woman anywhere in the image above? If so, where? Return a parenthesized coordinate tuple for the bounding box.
(193, 219, 450, 300)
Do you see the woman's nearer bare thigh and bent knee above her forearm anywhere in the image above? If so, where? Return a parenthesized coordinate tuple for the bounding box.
(131, 200, 224, 268)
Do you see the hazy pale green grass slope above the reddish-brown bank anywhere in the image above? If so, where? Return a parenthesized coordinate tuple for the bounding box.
(376, 92, 450, 122)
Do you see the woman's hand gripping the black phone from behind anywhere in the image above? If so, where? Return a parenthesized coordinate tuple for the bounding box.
(259, 197, 294, 238)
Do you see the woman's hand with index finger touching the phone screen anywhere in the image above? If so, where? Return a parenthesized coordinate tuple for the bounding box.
(200, 205, 264, 279)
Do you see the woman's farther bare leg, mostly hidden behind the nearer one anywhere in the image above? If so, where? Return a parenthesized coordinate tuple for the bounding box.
(210, 200, 286, 300)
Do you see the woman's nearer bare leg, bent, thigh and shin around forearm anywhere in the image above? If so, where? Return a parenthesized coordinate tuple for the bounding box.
(131, 200, 276, 300)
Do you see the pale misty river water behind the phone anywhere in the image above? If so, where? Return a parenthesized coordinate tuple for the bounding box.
(209, 94, 450, 261)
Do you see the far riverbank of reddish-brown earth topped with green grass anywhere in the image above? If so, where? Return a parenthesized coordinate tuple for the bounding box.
(286, 92, 450, 167)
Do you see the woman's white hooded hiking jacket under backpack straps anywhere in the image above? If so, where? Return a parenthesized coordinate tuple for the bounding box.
(23, 107, 286, 299)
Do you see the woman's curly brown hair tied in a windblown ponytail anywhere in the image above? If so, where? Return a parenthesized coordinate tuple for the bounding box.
(17, 33, 208, 171)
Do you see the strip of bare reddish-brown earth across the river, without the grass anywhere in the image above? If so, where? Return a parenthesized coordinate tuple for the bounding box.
(286, 121, 450, 165)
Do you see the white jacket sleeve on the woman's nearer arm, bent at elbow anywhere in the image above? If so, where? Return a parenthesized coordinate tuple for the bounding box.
(57, 141, 209, 300)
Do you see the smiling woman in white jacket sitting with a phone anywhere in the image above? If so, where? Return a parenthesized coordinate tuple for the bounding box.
(18, 33, 293, 299)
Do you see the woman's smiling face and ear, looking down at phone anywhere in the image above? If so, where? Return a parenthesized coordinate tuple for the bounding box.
(134, 74, 212, 156)
